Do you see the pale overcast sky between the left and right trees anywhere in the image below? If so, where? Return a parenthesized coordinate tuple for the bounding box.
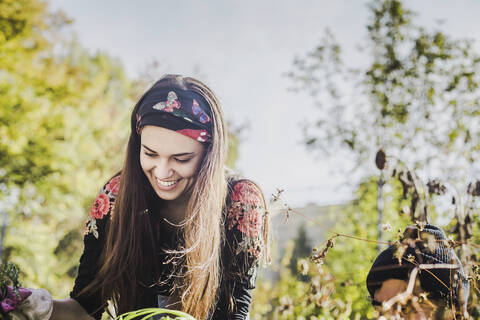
(49, 0, 480, 206)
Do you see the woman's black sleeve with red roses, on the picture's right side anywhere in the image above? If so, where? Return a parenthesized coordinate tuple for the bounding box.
(226, 180, 266, 320)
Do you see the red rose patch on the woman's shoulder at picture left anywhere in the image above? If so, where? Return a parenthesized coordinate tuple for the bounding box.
(85, 173, 120, 239)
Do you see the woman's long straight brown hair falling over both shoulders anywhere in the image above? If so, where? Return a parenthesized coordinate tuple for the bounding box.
(84, 75, 227, 319)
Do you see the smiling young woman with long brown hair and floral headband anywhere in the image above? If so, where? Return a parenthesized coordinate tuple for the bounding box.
(10, 75, 268, 320)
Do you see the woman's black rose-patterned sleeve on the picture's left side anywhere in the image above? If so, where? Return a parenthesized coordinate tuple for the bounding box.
(70, 175, 120, 320)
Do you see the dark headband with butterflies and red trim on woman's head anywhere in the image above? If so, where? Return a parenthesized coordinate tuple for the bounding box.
(135, 88, 212, 142)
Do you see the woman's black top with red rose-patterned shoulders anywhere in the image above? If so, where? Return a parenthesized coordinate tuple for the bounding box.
(70, 175, 265, 320)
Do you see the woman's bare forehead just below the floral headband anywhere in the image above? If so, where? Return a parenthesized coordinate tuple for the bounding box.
(141, 125, 204, 154)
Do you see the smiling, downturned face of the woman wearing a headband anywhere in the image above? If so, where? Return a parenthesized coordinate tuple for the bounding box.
(140, 125, 205, 200)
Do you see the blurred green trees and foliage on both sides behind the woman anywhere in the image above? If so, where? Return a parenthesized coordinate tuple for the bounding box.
(0, 0, 480, 319)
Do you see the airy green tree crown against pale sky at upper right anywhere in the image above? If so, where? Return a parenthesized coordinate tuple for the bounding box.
(288, 0, 480, 185)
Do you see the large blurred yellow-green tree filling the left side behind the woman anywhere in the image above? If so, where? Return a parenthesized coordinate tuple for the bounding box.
(0, 0, 238, 298)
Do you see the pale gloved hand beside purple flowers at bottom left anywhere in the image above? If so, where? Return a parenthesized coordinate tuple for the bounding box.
(8, 289, 53, 320)
